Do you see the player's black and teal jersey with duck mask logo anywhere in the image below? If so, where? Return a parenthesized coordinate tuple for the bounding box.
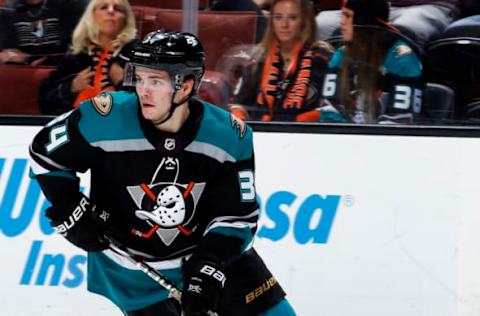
(30, 92, 258, 310)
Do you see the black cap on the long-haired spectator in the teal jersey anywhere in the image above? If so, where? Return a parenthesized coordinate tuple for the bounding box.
(345, 0, 390, 26)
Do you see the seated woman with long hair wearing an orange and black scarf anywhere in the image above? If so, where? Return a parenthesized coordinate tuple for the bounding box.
(231, 0, 332, 122)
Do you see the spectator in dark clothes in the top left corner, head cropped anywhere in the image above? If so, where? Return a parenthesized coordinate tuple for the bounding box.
(0, 0, 88, 65)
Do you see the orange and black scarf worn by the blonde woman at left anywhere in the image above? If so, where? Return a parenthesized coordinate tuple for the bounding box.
(73, 45, 115, 108)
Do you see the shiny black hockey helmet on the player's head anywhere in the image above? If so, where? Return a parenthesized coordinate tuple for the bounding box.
(124, 30, 205, 95)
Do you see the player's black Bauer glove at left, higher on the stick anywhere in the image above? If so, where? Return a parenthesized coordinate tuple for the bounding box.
(45, 193, 110, 251)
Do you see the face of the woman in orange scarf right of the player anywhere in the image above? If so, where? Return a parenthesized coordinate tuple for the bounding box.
(272, 0, 302, 44)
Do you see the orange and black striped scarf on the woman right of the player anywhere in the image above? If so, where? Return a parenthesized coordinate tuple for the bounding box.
(257, 41, 313, 121)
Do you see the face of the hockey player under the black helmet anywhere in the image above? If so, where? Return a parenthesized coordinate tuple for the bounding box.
(135, 67, 173, 124)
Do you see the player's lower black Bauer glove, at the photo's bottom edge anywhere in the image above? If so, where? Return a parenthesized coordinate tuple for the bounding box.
(182, 255, 226, 316)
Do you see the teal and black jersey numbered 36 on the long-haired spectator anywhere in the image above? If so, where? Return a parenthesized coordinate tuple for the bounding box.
(320, 40, 424, 123)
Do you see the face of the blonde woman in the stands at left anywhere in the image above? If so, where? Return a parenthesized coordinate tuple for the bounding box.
(93, 0, 126, 39)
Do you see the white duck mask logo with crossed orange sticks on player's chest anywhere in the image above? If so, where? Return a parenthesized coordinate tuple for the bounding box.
(127, 157, 205, 246)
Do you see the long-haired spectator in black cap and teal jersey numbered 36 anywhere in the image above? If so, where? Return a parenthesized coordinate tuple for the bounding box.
(320, 0, 423, 124)
